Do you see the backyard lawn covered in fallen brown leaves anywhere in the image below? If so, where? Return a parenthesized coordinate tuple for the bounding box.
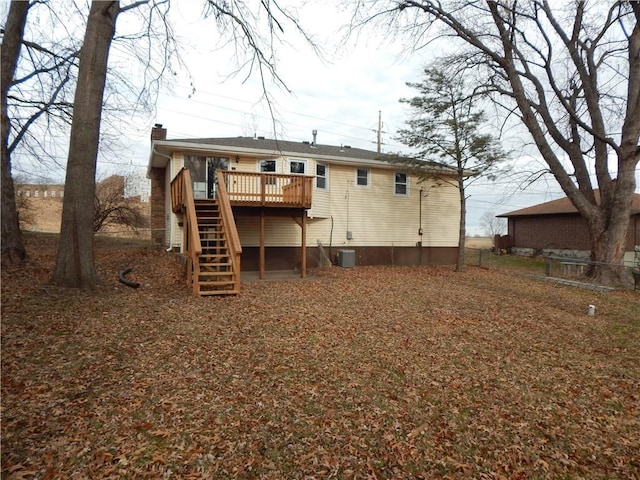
(2, 235, 640, 479)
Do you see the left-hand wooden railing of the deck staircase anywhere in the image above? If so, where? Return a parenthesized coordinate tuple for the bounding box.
(171, 168, 201, 295)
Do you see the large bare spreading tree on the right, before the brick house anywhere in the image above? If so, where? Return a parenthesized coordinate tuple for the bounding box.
(354, 0, 640, 283)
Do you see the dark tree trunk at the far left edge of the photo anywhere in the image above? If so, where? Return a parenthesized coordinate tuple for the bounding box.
(0, 1, 29, 267)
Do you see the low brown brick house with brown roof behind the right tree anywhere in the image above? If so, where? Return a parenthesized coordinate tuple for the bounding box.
(496, 194, 640, 265)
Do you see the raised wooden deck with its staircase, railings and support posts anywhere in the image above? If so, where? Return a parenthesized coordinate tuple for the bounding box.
(171, 168, 313, 295)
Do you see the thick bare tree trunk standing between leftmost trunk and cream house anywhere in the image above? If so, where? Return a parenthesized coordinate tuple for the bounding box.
(52, 0, 120, 289)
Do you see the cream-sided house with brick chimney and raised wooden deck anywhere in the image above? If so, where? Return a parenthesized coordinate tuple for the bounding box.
(147, 125, 460, 294)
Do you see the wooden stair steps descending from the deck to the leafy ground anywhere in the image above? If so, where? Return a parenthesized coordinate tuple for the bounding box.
(193, 199, 239, 295)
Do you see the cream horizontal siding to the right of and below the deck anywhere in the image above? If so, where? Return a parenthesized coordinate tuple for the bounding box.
(236, 165, 460, 248)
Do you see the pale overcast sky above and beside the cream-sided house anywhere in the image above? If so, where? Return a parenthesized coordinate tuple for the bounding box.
(3, 0, 640, 235)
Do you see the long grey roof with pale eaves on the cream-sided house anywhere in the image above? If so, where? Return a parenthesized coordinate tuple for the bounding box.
(149, 137, 455, 175)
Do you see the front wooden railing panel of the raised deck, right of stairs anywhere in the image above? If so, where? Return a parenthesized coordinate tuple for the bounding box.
(220, 170, 313, 208)
